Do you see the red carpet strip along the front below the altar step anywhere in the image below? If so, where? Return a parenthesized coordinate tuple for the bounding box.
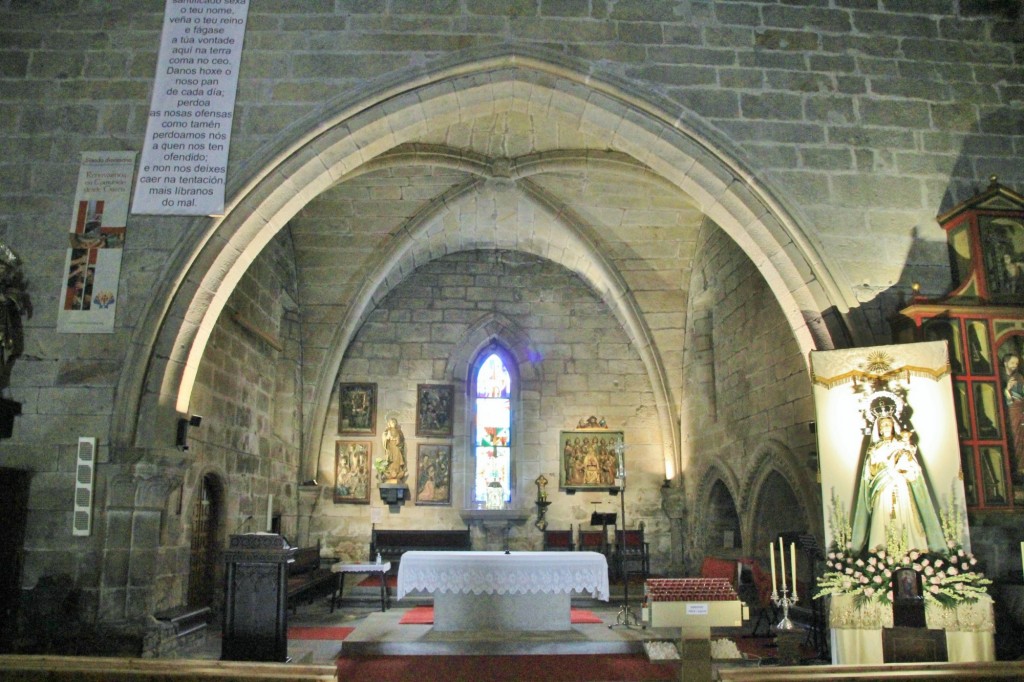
(338, 654, 679, 682)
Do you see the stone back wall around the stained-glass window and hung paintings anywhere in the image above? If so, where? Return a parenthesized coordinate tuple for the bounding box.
(313, 246, 668, 560)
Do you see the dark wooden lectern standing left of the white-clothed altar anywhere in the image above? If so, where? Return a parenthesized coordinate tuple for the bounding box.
(220, 532, 294, 663)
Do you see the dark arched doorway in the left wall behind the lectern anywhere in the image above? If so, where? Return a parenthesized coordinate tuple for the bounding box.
(188, 474, 223, 607)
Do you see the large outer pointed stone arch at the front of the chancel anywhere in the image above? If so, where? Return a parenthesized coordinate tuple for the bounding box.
(113, 46, 850, 481)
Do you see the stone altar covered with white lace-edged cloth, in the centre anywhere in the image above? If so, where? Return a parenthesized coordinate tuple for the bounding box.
(396, 552, 608, 631)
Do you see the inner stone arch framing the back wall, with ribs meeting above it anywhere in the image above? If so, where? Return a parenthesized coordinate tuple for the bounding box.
(303, 151, 679, 478)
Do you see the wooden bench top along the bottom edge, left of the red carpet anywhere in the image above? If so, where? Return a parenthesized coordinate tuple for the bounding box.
(0, 655, 338, 682)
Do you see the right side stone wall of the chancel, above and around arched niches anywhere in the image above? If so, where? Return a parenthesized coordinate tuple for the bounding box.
(682, 224, 822, 571)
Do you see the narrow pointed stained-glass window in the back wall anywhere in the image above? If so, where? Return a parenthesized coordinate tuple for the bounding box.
(470, 345, 517, 502)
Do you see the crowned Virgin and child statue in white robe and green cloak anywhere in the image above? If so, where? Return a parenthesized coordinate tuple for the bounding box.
(852, 394, 945, 552)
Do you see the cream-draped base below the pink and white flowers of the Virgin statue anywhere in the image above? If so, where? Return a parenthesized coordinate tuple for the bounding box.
(828, 595, 995, 665)
